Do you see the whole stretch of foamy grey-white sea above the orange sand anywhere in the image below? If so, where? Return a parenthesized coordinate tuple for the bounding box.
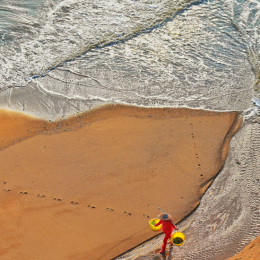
(0, 0, 260, 118)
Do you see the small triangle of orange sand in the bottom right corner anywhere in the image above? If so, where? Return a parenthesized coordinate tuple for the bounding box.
(227, 237, 260, 260)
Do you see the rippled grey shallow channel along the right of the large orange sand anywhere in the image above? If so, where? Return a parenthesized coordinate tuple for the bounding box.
(172, 117, 260, 260)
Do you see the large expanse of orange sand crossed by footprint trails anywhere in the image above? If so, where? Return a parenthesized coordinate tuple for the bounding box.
(0, 105, 239, 260)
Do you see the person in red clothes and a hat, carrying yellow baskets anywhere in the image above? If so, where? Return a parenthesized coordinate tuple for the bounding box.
(155, 213, 177, 254)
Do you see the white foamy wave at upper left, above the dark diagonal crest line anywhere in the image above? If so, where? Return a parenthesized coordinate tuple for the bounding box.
(0, 0, 201, 89)
